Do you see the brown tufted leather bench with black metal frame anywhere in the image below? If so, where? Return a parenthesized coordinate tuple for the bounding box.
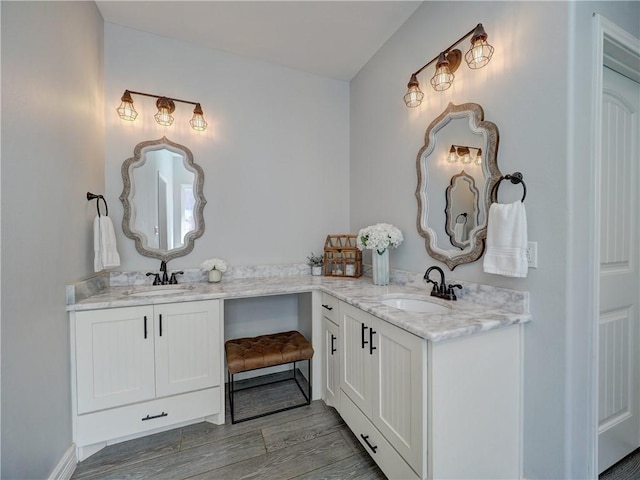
(224, 330, 313, 423)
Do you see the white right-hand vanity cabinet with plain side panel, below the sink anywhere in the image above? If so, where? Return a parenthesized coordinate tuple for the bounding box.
(339, 302, 522, 480)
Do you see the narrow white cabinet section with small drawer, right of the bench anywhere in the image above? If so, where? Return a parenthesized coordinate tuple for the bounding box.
(322, 293, 341, 412)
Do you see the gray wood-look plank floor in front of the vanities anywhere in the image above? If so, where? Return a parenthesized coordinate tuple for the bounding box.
(72, 374, 385, 480)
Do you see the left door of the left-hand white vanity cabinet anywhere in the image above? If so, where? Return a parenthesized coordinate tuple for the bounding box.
(76, 307, 155, 414)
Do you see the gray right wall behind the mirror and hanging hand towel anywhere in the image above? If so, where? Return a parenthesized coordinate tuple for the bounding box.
(350, 2, 640, 478)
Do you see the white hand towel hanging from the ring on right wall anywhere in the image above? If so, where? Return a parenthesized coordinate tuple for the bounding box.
(483, 201, 529, 277)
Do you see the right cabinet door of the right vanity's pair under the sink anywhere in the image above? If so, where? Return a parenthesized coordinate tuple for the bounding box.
(371, 319, 427, 474)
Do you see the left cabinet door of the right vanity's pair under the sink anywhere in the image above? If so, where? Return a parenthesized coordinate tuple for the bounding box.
(340, 303, 372, 415)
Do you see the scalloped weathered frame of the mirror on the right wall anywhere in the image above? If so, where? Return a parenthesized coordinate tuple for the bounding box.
(415, 103, 502, 270)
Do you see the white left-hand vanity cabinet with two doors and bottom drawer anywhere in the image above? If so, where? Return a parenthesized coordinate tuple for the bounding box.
(71, 300, 224, 459)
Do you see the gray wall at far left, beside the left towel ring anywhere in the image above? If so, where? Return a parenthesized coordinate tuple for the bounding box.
(1, 1, 104, 479)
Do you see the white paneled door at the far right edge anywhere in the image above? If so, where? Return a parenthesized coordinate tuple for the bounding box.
(598, 64, 640, 472)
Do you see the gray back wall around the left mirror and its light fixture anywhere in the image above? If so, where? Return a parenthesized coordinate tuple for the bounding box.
(104, 23, 349, 270)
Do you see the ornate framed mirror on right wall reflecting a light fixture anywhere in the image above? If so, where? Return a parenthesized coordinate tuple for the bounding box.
(415, 103, 501, 270)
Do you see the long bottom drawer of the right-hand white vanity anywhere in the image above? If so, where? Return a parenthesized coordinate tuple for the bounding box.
(340, 391, 420, 480)
